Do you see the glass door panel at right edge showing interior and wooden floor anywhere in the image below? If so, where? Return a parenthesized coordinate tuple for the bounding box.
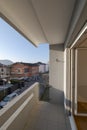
(75, 48, 87, 114)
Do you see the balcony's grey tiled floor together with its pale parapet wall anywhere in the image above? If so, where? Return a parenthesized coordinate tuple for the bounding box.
(0, 83, 71, 130)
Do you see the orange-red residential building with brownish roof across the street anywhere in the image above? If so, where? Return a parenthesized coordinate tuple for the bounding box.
(11, 62, 38, 78)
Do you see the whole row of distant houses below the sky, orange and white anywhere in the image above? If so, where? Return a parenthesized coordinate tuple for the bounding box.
(0, 62, 48, 78)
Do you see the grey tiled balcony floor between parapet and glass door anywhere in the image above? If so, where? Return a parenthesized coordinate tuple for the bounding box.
(23, 88, 71, 130)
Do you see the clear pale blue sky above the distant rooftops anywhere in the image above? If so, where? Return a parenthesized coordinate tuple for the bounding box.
(0, 18, 49, 63)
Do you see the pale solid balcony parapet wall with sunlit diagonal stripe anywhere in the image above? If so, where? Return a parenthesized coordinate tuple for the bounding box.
(0, 83, 39, 130)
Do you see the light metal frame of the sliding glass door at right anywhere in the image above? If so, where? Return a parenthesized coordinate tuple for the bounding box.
(70, 22, 87, 116)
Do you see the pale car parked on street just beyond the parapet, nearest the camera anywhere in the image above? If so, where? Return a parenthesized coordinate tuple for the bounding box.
(0, 93, 18, 108)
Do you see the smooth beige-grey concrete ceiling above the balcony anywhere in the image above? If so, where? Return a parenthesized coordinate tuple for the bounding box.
(0, 0, 76, 46)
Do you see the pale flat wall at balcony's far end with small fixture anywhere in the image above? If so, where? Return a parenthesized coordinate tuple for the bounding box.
(49, 45, 64, 91)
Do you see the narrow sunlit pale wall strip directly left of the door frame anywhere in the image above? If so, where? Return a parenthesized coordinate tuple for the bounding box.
(64, 48, 71, 114)
